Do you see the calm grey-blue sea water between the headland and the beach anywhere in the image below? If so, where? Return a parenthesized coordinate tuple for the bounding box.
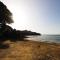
(27, 35, 60, 43)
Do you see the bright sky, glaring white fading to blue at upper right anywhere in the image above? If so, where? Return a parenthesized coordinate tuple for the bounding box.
(0, 0, 60, 34)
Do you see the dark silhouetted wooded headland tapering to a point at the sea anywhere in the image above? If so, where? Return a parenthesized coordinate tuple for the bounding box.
(0, 25, 41, 40)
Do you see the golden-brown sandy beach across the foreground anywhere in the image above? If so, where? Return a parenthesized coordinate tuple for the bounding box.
(0, 41, 60, 60)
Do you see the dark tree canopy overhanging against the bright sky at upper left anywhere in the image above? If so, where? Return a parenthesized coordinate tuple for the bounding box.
(0, 1, 13, 24)
